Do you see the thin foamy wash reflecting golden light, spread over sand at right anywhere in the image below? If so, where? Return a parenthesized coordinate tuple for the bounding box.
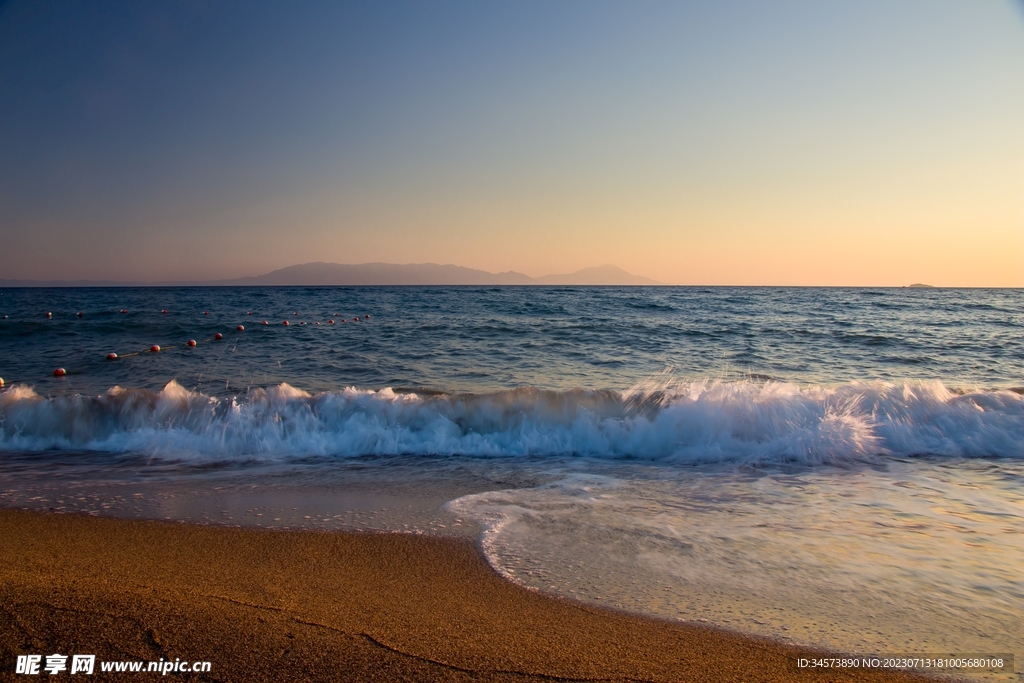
(446, 459, 1024, 680)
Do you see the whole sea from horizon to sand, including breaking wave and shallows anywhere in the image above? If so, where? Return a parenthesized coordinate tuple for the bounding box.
(0, 287, 1024, 681)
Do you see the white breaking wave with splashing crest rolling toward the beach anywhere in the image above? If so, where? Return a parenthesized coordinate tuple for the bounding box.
(0, 380, 1024, 465)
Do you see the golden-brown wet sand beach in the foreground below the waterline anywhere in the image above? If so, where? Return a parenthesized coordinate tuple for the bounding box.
(0, 510, 927, 681)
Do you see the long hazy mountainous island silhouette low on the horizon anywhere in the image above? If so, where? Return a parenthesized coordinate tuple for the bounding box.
(0, 262, 662, 287)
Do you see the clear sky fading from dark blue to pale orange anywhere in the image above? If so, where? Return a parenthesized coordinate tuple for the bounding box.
(0, 0, 1024, 287)
